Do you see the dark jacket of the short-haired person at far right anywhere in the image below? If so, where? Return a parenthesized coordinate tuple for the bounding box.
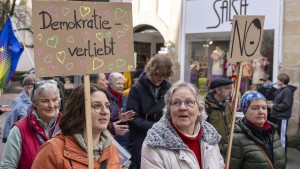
(271, 85, 297, 119)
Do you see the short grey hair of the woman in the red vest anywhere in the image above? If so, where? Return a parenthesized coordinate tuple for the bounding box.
(30, 80, 60, 104)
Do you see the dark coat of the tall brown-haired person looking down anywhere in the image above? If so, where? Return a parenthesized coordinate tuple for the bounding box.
(126, 73, 171, 165)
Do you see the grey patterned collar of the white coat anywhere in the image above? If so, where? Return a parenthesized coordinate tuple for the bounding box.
(145, 113, 221, 149)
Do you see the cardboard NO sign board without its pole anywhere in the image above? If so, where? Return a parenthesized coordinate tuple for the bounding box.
(228, 15, 264, 63)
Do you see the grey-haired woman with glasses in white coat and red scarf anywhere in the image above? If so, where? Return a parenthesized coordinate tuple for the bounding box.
(141, 82, 224, 169)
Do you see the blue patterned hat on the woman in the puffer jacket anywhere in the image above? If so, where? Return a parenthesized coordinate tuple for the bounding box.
(240, 90, 266, 114)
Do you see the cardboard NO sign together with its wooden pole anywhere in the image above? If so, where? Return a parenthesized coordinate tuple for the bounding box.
(225, 15, 264, 169)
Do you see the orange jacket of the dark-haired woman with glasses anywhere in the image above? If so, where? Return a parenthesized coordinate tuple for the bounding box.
(32, 132, 121, 169)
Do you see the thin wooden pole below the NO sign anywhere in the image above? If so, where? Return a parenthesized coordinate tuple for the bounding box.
(225, 62, 243, 169)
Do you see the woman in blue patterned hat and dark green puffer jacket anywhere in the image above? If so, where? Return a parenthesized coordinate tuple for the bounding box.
(221, 91, 286, 169)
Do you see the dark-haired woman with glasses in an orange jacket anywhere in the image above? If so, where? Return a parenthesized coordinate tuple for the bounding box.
(32, 84, 121, 169)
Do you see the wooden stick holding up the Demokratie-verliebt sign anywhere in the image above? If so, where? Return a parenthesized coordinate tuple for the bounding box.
(84, 75, 94, 169)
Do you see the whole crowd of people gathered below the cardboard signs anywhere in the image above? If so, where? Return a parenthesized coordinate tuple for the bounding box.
(0, 54, 296, 169)
